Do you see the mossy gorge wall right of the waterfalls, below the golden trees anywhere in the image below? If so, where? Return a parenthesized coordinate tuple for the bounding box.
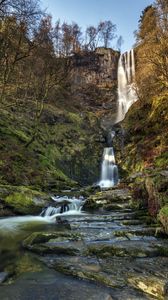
(114, 92, 168, 233)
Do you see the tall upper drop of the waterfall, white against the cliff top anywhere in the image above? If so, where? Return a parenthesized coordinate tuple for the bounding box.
(115, 49, 137, 124)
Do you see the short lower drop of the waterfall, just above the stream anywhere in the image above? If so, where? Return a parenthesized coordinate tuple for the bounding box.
(98, 147, 118, 188)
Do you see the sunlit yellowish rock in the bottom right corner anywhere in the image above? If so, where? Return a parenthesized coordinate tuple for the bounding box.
(128, 275, 168, 299)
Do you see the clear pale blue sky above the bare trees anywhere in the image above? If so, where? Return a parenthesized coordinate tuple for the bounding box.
(41, 0, 153, 52)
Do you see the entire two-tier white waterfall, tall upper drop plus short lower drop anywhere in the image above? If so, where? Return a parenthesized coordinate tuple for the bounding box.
(98, 49, 137, 188)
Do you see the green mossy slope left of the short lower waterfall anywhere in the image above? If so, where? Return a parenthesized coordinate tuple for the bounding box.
(0, 95, 103, 191)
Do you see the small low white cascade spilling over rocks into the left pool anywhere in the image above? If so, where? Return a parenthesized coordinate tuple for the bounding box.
(40, 196, 85, 217)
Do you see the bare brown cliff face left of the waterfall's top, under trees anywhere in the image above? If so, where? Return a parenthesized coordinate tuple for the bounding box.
(72, 48, 119, 88)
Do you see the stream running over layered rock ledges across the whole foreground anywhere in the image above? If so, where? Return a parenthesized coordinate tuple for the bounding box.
(0, 191, 168, 300)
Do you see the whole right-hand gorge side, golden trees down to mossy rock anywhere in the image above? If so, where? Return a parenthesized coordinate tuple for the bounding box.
(117, 0, 168, 225)
